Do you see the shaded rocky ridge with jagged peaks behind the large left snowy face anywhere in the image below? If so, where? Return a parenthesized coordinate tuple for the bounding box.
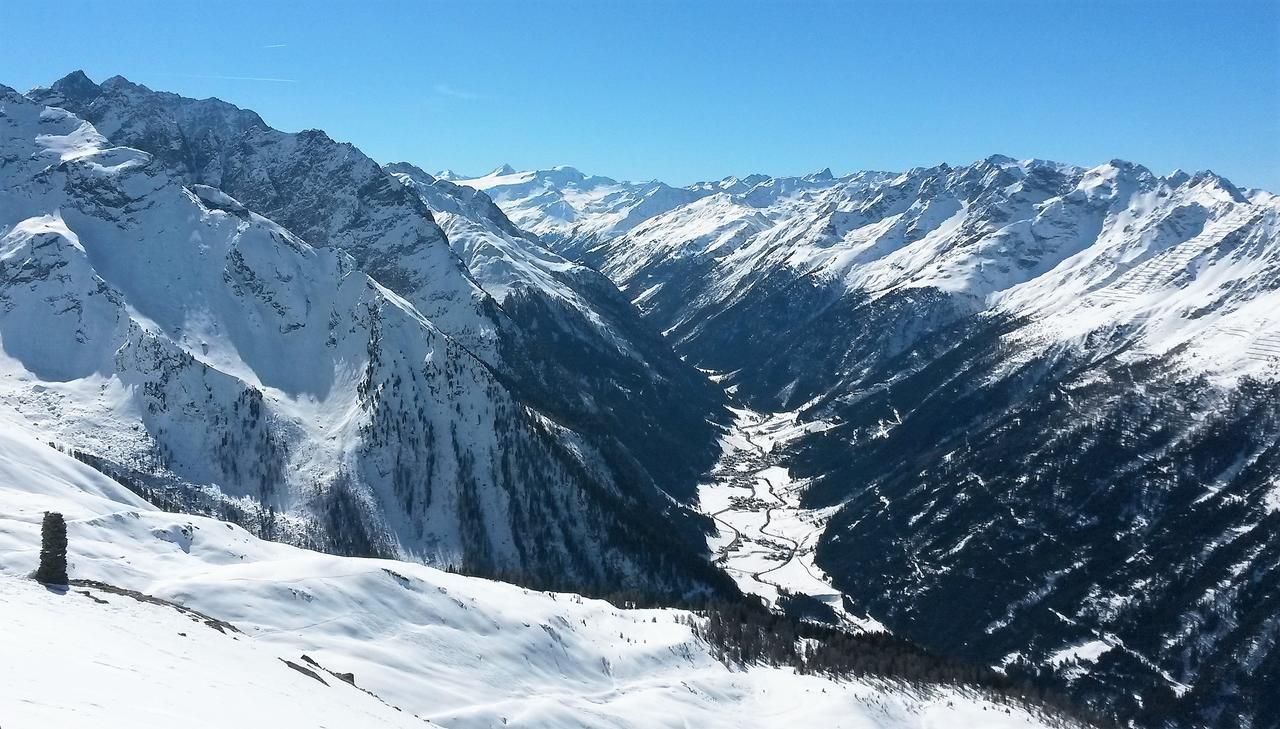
(28, 72, 497, 361)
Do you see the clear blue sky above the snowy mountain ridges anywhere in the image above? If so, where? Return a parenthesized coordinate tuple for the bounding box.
(0, 0, 1280, 191)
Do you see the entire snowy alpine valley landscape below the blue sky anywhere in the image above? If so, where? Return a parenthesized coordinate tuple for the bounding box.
(0, 72, 1280, 728)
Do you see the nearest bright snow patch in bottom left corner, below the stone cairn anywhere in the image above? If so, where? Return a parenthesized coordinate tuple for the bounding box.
(0, 576, 425, 729)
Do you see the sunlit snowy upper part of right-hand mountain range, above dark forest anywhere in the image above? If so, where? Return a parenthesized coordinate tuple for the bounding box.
(555, 157, 1280, 393)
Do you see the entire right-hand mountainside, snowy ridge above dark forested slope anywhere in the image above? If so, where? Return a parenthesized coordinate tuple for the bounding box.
(478, 156, 1280, 726)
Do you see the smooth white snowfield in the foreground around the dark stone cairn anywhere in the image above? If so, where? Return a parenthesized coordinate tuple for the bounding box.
(0, 427, 1059, 729)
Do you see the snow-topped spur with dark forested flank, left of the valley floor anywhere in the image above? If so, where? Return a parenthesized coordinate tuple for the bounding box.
(388, 162, 726, 503)
